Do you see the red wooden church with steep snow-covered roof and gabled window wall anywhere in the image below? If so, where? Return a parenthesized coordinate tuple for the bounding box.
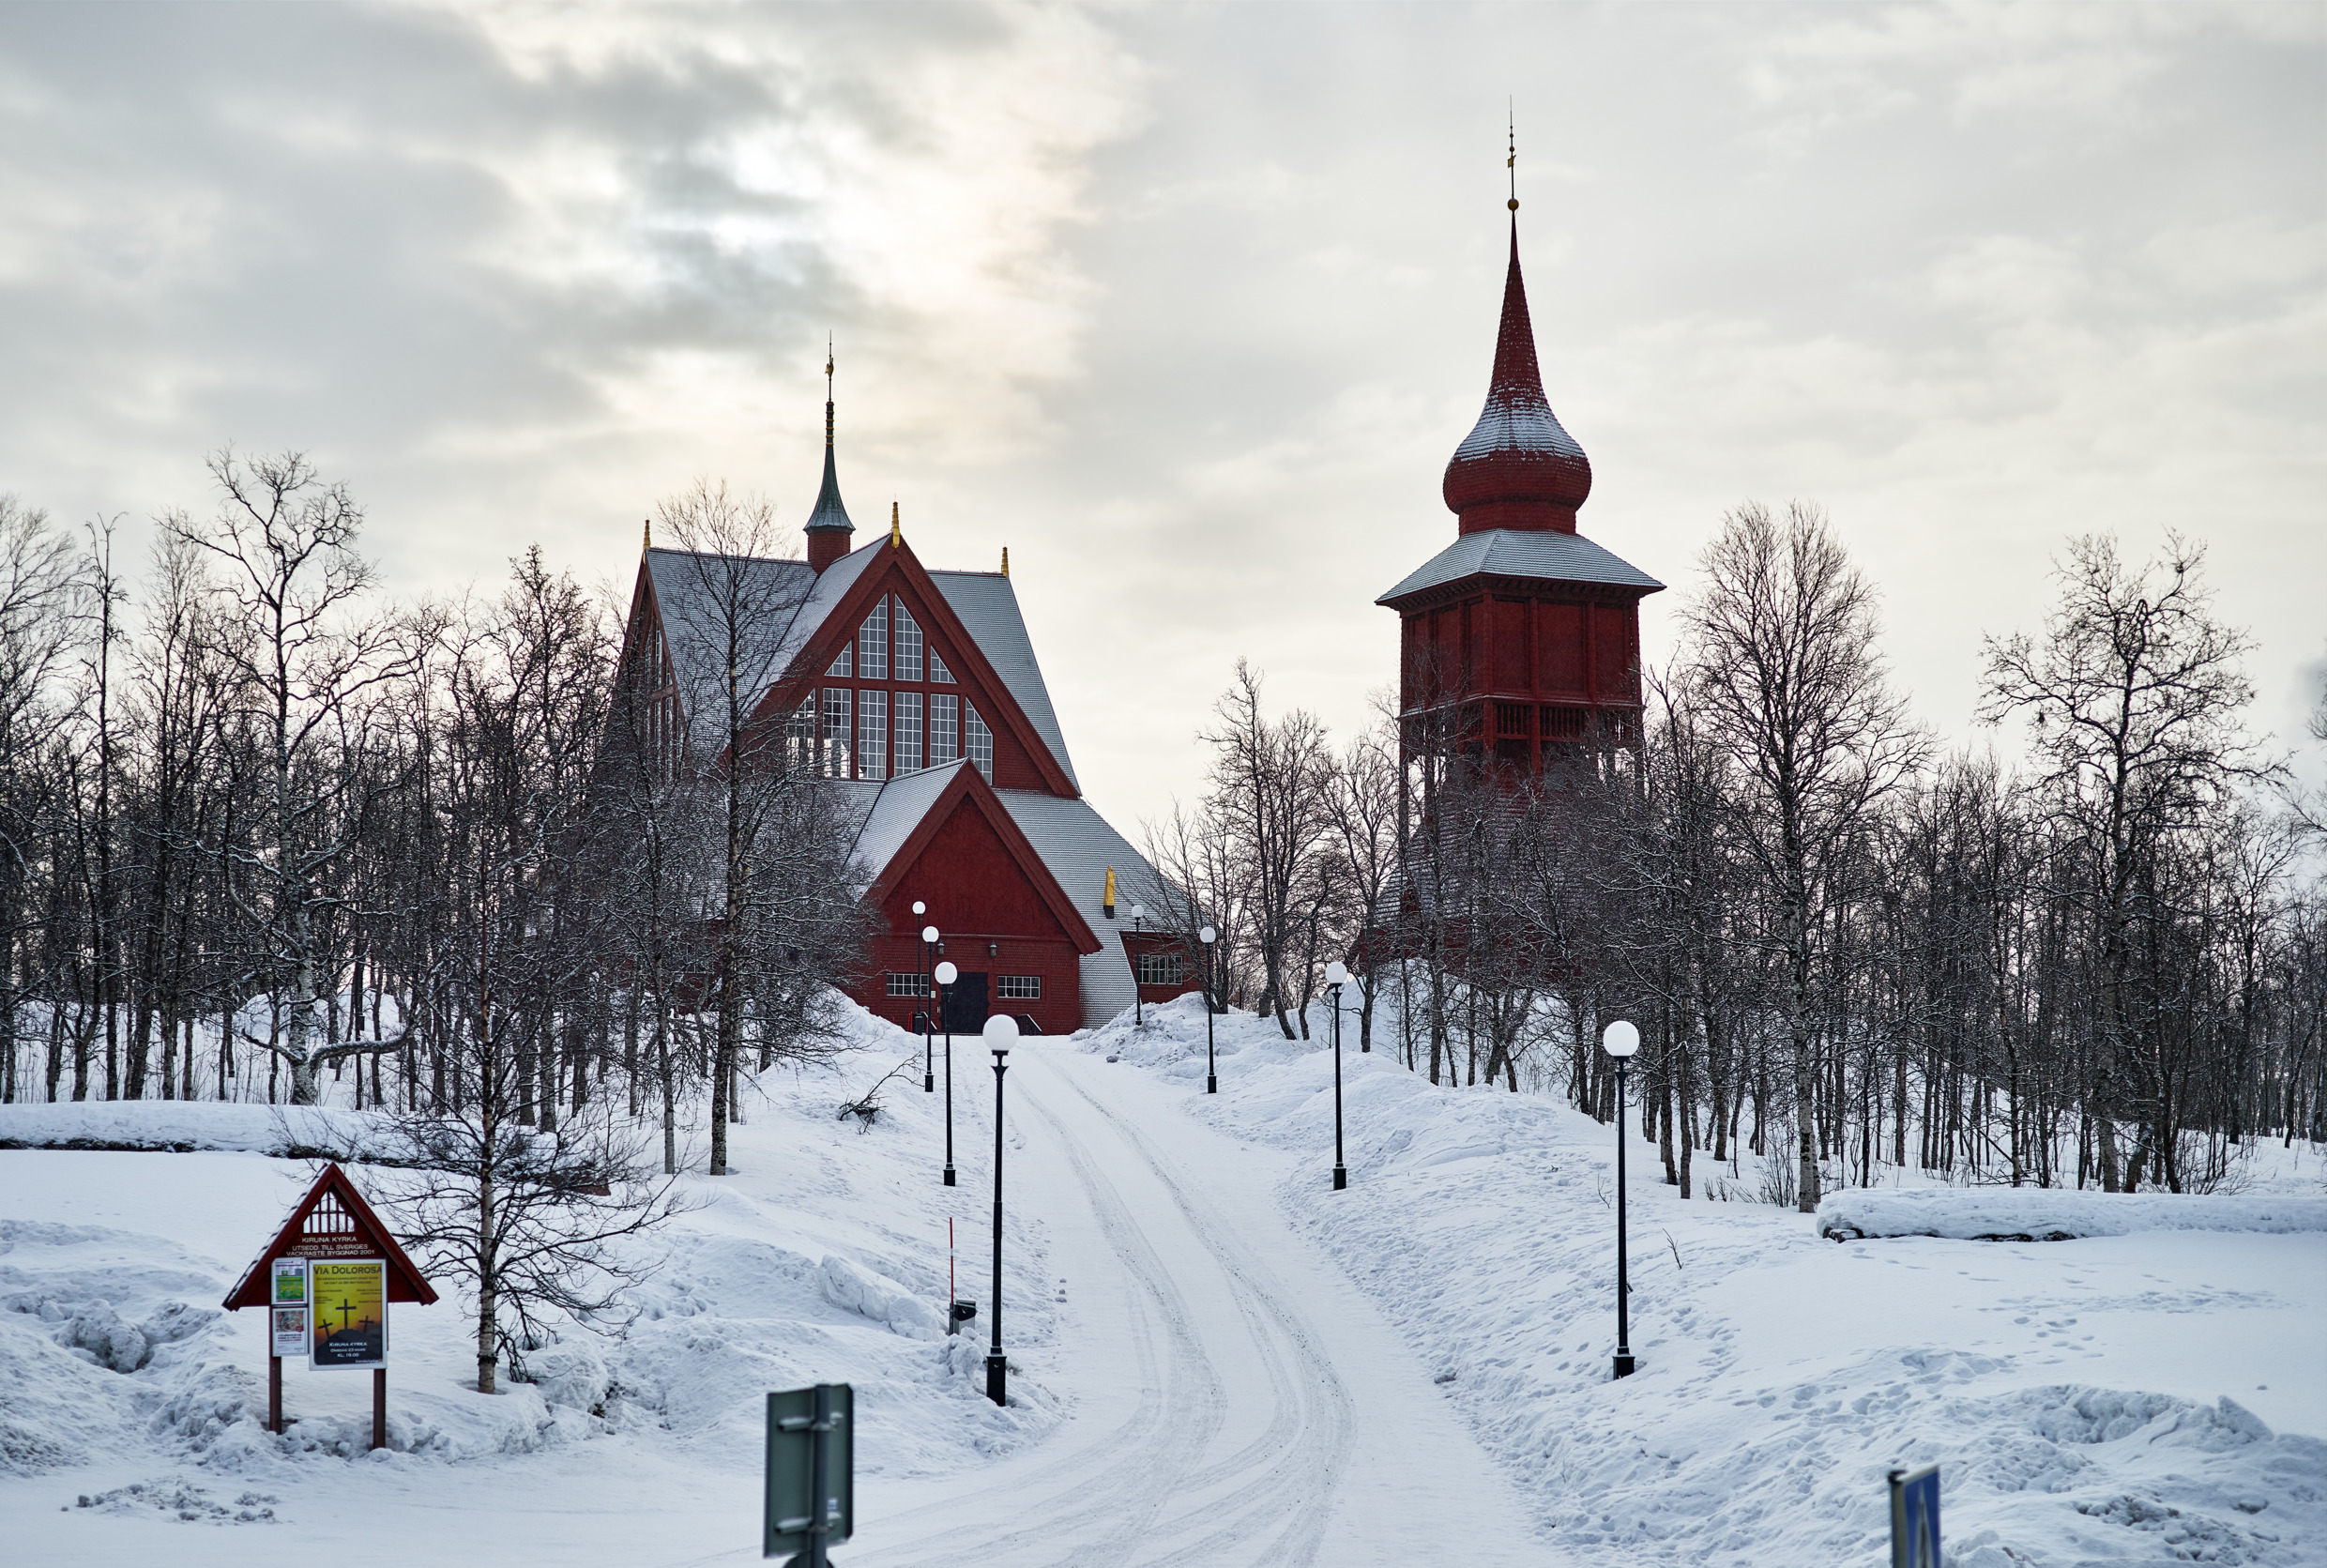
(621, 384, 1194, 1033)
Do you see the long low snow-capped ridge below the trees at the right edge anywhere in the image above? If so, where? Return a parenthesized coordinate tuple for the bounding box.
(1817, 1186, 2327, 1242)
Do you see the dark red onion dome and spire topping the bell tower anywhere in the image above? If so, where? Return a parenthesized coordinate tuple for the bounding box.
(1443, 205, 1591, 533)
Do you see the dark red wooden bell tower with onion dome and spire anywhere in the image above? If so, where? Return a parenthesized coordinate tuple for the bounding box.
(1376, 128, 1664, 777)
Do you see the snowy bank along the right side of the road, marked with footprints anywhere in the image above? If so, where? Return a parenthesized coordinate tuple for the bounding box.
(1077, 998, 2327, 1568)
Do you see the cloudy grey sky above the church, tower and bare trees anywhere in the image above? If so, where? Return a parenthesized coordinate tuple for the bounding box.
(0, 2, 2327, 829)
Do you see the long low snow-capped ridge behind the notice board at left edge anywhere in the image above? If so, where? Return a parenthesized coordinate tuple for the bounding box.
(0, 1101, 382, 1161)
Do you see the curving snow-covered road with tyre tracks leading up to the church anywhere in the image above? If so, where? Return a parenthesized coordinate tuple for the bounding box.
(835, 1043, 1559, 1568)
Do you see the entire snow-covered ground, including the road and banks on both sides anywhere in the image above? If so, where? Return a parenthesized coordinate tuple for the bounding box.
(0, 1000, 2327, 1568)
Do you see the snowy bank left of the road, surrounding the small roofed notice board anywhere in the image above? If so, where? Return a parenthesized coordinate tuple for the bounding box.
(0, 1010, 1061, 1563)
